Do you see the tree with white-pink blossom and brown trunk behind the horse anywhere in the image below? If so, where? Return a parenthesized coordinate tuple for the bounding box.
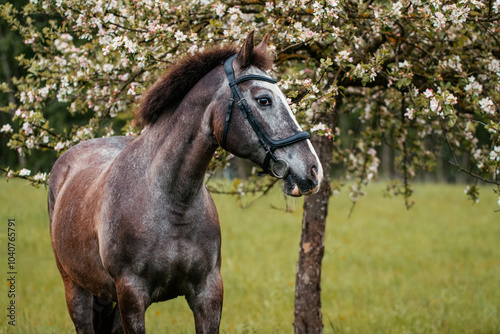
(0, 0, 500, 332)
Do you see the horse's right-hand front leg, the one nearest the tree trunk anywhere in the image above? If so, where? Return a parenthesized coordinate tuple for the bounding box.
(186, 269, 223, 334)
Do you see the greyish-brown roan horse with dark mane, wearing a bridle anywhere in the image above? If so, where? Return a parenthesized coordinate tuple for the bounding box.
(48, 32, 323, 333)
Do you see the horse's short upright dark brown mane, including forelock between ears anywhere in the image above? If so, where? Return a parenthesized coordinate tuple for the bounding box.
(134, 45, 273, 125)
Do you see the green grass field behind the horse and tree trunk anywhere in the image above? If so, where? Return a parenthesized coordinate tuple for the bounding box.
(0, 179, 500, 334)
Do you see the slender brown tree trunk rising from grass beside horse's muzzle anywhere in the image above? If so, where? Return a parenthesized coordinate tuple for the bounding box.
(294, 108, 337, 334)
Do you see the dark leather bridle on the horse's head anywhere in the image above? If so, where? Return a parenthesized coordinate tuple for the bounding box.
(222, 55, 311, 179)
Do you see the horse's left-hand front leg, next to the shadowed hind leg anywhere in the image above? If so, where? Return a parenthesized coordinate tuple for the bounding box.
(116, 278, 150, 334)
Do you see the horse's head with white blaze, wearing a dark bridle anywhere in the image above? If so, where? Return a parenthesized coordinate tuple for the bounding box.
(217, 33, 323, 196)
